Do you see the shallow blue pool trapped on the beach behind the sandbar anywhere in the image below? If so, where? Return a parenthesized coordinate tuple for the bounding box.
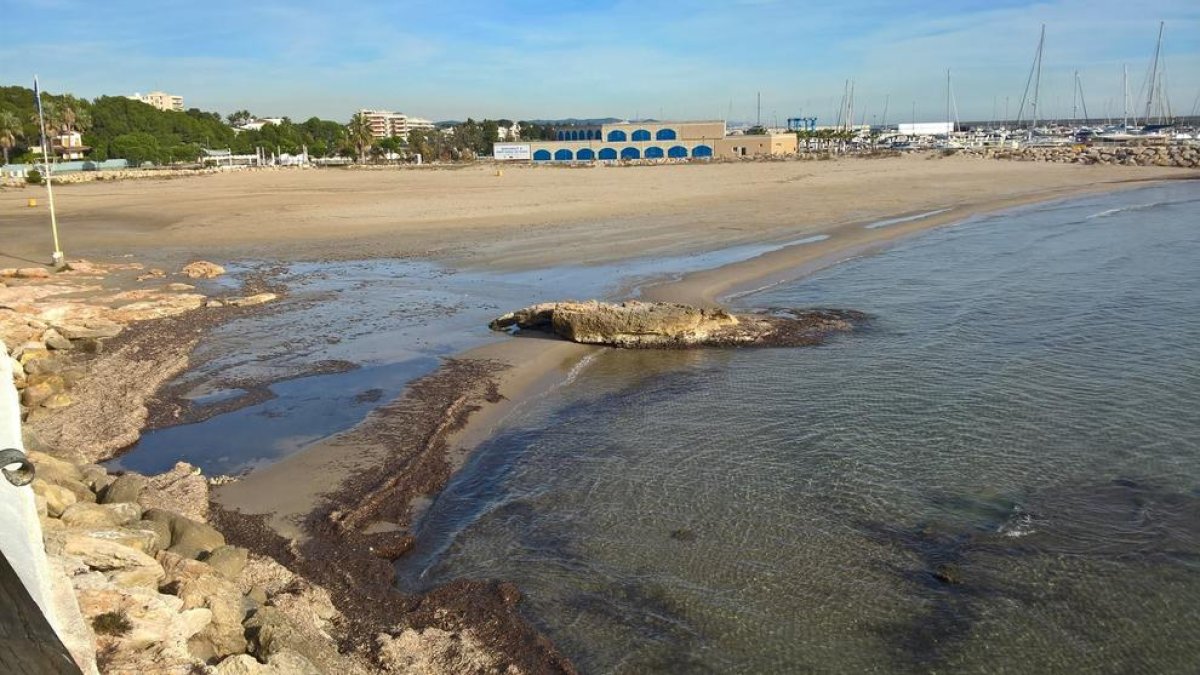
(117, 234, 840, 476)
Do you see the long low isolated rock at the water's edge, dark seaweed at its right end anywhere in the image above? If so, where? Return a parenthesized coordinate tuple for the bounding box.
(488, 300, 866, 350)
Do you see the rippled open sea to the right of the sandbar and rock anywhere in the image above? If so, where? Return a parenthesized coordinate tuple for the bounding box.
(398, 183, 1200, 673)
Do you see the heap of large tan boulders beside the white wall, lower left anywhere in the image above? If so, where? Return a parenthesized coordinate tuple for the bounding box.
(29, 452, 370, 675)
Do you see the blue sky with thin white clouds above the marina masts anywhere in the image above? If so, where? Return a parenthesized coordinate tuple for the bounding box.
(0, 0, 1200, 125)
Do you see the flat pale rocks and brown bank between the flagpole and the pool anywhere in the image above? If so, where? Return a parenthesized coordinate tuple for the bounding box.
(0, 261, 276, 461)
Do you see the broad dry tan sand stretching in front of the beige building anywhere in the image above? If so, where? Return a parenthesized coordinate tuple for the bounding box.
(0, 155, 1188, 268)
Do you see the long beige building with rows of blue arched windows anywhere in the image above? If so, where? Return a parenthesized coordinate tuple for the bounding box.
(529, 121, 797, 162)
